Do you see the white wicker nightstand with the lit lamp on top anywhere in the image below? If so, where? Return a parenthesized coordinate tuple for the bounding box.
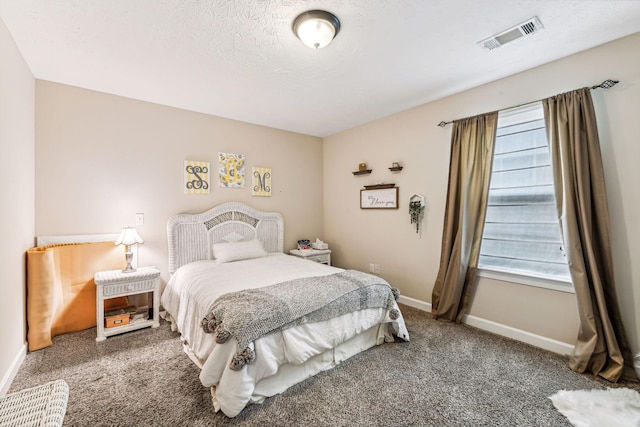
(94, 267, 160, 342)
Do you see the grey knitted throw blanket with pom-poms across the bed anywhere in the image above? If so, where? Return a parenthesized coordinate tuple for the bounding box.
(202, 270, 400, 371)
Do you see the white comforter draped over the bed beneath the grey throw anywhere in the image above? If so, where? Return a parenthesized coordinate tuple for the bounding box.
(161, 254, 409, 417)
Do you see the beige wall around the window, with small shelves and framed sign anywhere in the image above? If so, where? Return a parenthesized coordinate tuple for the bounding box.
(324, 34, 640, 352)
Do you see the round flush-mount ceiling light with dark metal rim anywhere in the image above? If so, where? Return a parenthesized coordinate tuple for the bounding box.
(293, 10, 340, 49)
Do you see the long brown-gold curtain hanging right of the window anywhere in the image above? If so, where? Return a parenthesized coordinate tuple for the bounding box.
(543, 88, 636, 382)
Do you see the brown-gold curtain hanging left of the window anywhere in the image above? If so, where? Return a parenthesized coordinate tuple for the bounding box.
(431, 112, 498, 323)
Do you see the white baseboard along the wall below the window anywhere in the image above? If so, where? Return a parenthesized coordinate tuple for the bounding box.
(399, 295, 573, 356)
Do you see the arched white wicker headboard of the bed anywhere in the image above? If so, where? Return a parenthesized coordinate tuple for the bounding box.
(167, 202, 284, 274)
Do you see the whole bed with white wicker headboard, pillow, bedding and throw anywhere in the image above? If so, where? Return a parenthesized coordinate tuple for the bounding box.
(161, 203, 409, 417)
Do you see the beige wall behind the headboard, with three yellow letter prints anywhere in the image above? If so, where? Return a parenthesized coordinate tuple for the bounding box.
(36, 81, 323, 286)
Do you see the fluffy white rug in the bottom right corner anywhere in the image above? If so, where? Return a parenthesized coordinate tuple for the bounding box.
(549, 388, 640, 427)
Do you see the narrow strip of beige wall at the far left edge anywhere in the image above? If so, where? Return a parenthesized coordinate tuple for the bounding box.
(0, 20, 35, 394)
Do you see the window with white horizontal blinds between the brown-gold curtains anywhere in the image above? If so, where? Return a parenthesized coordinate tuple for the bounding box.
(479, 102, 573, 291)
